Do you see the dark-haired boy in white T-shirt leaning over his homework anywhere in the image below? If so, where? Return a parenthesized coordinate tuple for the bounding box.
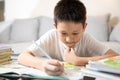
(18, 0, 117, 75)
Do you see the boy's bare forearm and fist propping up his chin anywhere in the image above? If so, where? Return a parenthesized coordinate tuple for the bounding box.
(64, 49, 118, 66)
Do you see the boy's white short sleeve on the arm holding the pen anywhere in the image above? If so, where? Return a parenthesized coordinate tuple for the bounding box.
(28, 29, 54, 56)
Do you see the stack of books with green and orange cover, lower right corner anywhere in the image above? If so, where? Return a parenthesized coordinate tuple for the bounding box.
(81, 56, 120, 80)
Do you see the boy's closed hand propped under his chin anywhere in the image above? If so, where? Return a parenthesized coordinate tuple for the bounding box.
(64, 48, 77, 64)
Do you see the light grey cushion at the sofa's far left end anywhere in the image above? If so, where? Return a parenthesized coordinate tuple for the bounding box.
(0, 21, 13, 43)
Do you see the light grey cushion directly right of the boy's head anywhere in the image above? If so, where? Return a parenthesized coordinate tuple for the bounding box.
(86, 14, 110, 41)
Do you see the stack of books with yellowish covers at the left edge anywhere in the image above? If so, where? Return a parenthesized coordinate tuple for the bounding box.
(0, 45, 13, 64)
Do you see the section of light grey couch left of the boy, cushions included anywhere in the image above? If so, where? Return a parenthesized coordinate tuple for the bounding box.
(0, 16, 54, 53)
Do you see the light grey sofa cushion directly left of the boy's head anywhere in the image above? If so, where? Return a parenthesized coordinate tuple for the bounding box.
(39, 16, 54, 37)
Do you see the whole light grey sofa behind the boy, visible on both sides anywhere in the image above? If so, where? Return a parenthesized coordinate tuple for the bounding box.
(0, 14, 120, 54)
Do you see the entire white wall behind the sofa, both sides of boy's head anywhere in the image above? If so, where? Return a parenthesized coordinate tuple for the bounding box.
(5, 0, 120, 20)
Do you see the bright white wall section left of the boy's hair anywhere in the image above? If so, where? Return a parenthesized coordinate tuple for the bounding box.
(5, 0, 59, 20)
